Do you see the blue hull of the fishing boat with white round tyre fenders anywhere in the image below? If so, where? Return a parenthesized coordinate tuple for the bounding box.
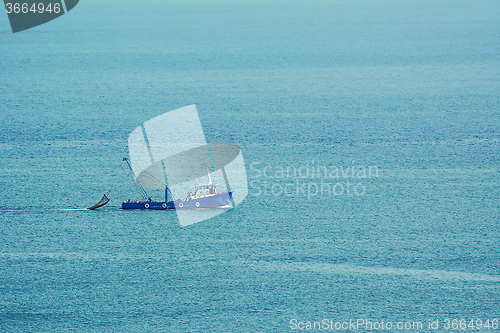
(122, 192, 233, 210)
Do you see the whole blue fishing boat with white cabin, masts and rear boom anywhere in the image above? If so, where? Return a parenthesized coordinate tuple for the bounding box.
(122, 157, 233, 210)
